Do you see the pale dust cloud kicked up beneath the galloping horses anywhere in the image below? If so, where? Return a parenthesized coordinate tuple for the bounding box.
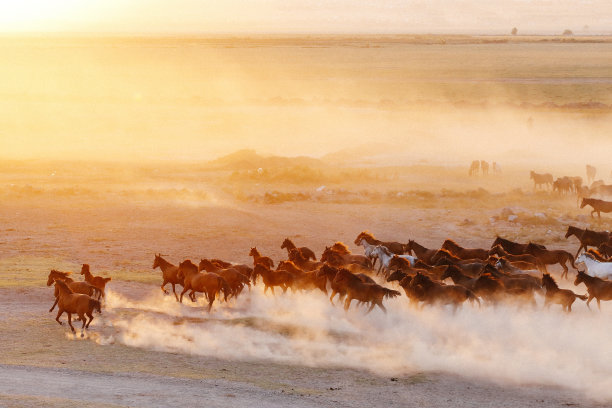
(98, 288, 612, 400)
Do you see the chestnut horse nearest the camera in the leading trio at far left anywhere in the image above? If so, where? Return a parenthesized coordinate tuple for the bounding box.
(55, 279, 102, 337)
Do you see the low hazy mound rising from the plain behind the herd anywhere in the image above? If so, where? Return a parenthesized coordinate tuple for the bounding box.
(208, 149, 325, 170)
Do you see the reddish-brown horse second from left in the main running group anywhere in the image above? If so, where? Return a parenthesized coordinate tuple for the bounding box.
(178, 259, 231, 313)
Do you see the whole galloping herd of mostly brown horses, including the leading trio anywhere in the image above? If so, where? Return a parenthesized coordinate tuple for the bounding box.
(47, 226, 612, 336)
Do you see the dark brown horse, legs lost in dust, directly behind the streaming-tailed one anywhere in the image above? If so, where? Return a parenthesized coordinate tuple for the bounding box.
(410, 272, 480, 310)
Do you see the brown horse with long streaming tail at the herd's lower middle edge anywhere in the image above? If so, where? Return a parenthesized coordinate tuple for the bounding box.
(334, 269, 401, 314)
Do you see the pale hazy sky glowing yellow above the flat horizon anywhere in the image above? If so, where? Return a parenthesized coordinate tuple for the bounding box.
(0, 0, 612, 34)
